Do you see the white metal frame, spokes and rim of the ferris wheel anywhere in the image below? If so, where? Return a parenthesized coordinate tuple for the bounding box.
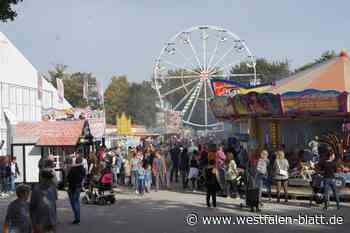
(153, 25, 257, 130)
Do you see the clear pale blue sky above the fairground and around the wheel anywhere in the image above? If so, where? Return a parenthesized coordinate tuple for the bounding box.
(0, 0, 350, 86)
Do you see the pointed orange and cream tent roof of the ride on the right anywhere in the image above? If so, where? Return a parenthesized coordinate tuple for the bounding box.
(266, 52, 350, 94)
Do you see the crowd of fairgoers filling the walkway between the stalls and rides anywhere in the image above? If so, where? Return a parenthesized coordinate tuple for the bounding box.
(0, 138, 340, 233)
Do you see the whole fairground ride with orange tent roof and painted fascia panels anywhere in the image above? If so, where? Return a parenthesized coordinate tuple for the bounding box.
(211, 52, 350, 186)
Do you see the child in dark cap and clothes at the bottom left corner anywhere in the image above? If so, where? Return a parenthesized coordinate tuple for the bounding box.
(3, 184, 32, 233)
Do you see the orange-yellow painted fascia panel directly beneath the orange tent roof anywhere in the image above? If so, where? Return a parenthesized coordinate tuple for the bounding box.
(281, 89, 347, 115)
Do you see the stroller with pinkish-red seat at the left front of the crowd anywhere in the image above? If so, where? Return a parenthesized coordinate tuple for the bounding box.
(82, 169, 115, 205)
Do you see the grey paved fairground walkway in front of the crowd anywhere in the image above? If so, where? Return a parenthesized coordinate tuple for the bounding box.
(0, 189, 350, 233)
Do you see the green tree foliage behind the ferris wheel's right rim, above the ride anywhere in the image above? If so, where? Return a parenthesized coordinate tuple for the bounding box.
(231, 58, 291, 84)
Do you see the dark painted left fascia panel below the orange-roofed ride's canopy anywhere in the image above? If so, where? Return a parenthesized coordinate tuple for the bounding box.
(230, 92, 282, 116)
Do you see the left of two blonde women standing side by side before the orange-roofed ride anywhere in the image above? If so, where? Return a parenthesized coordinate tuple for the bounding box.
(256, 150, 270, 206)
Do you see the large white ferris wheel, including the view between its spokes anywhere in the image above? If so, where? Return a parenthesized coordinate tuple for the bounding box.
(153, 25, 257, 130)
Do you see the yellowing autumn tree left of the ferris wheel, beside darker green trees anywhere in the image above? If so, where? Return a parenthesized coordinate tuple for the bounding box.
(104, 76, 129, 124)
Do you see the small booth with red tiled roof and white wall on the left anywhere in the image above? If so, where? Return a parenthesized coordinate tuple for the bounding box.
(11, 120, 93, 183)
